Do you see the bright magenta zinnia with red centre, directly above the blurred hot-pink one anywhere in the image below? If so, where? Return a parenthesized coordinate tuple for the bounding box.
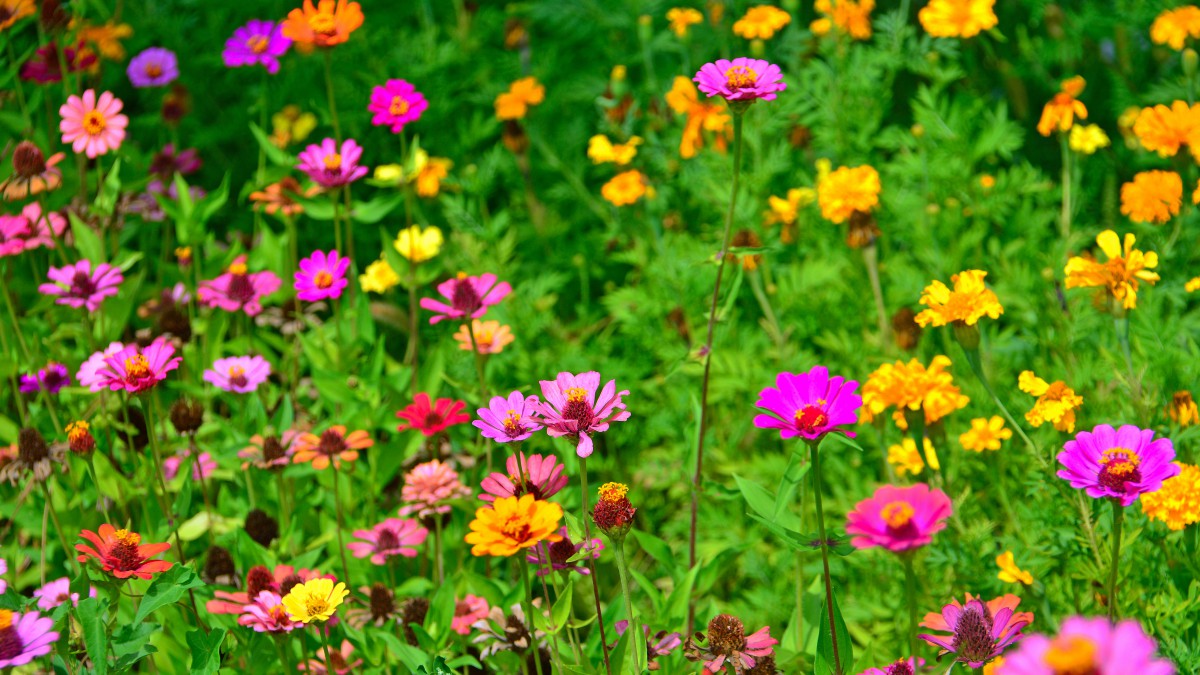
(754, 365, 863, 441)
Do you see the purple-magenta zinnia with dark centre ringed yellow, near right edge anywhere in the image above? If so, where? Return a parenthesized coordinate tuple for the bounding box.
(1058, 424, 1180, 506)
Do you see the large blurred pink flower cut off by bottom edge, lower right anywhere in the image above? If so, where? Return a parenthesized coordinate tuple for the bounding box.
(997, 616, 1175, 675)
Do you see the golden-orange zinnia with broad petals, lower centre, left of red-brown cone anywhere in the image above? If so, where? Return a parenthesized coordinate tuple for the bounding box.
(464, 495, 563, 557)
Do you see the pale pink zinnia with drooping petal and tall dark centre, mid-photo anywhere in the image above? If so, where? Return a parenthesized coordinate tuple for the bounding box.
(536, 370, 629, 458)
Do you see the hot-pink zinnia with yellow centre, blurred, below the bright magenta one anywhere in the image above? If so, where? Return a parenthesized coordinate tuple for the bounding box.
(846, 483, 953, 552)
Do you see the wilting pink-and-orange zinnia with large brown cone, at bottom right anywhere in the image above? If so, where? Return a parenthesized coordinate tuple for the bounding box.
(918, 593, 1033, 668)
